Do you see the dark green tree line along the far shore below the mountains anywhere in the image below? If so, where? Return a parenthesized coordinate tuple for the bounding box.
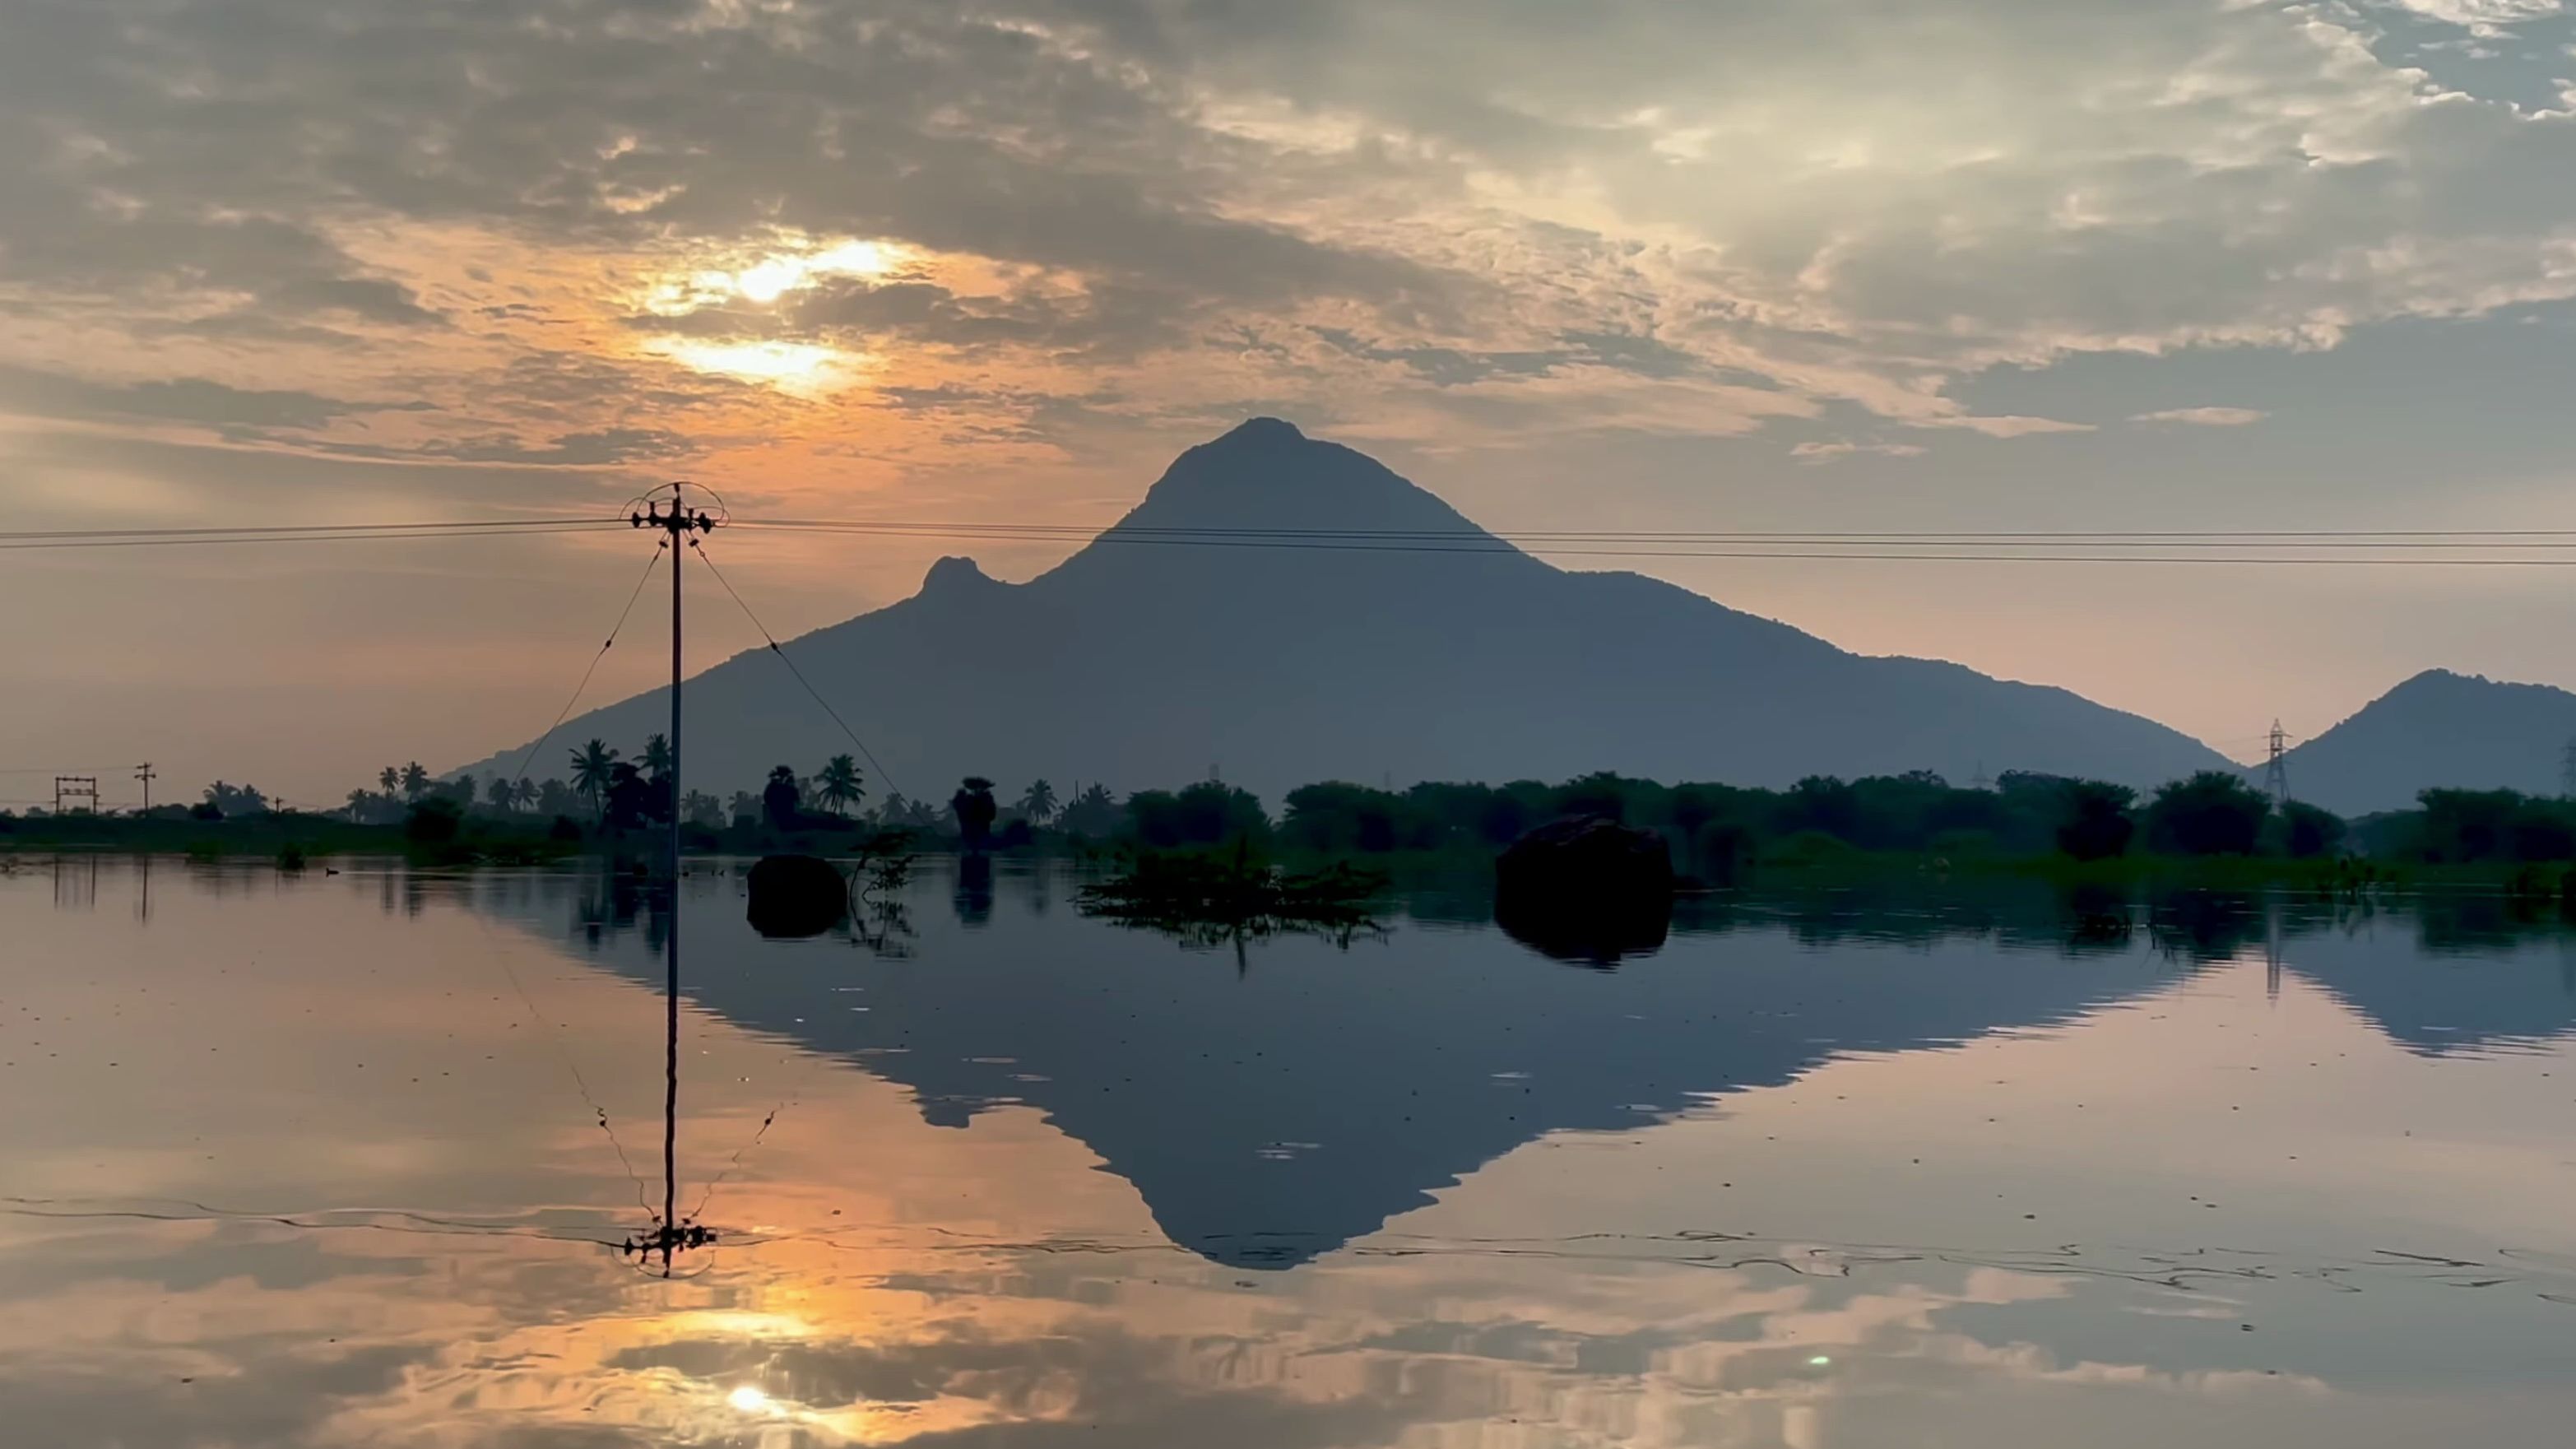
(292, 735, 2576, 874)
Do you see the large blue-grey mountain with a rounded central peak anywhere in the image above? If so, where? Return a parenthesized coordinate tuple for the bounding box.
(466, 418, 2230, 802)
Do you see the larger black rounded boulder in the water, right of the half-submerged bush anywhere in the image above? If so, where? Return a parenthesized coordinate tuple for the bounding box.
(1494, 815, 1674, 964)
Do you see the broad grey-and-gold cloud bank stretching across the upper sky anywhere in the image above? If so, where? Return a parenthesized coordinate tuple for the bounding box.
(0, 0, 2576, 474)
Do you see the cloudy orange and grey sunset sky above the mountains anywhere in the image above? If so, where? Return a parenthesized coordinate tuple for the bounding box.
(0, 0, 2576, 805)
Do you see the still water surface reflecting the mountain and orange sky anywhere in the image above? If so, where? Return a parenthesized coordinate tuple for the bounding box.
(0, 858, 2576, 1449)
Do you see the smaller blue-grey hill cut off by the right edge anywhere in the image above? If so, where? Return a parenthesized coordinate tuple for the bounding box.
(2251, 671, 2576, 815)
